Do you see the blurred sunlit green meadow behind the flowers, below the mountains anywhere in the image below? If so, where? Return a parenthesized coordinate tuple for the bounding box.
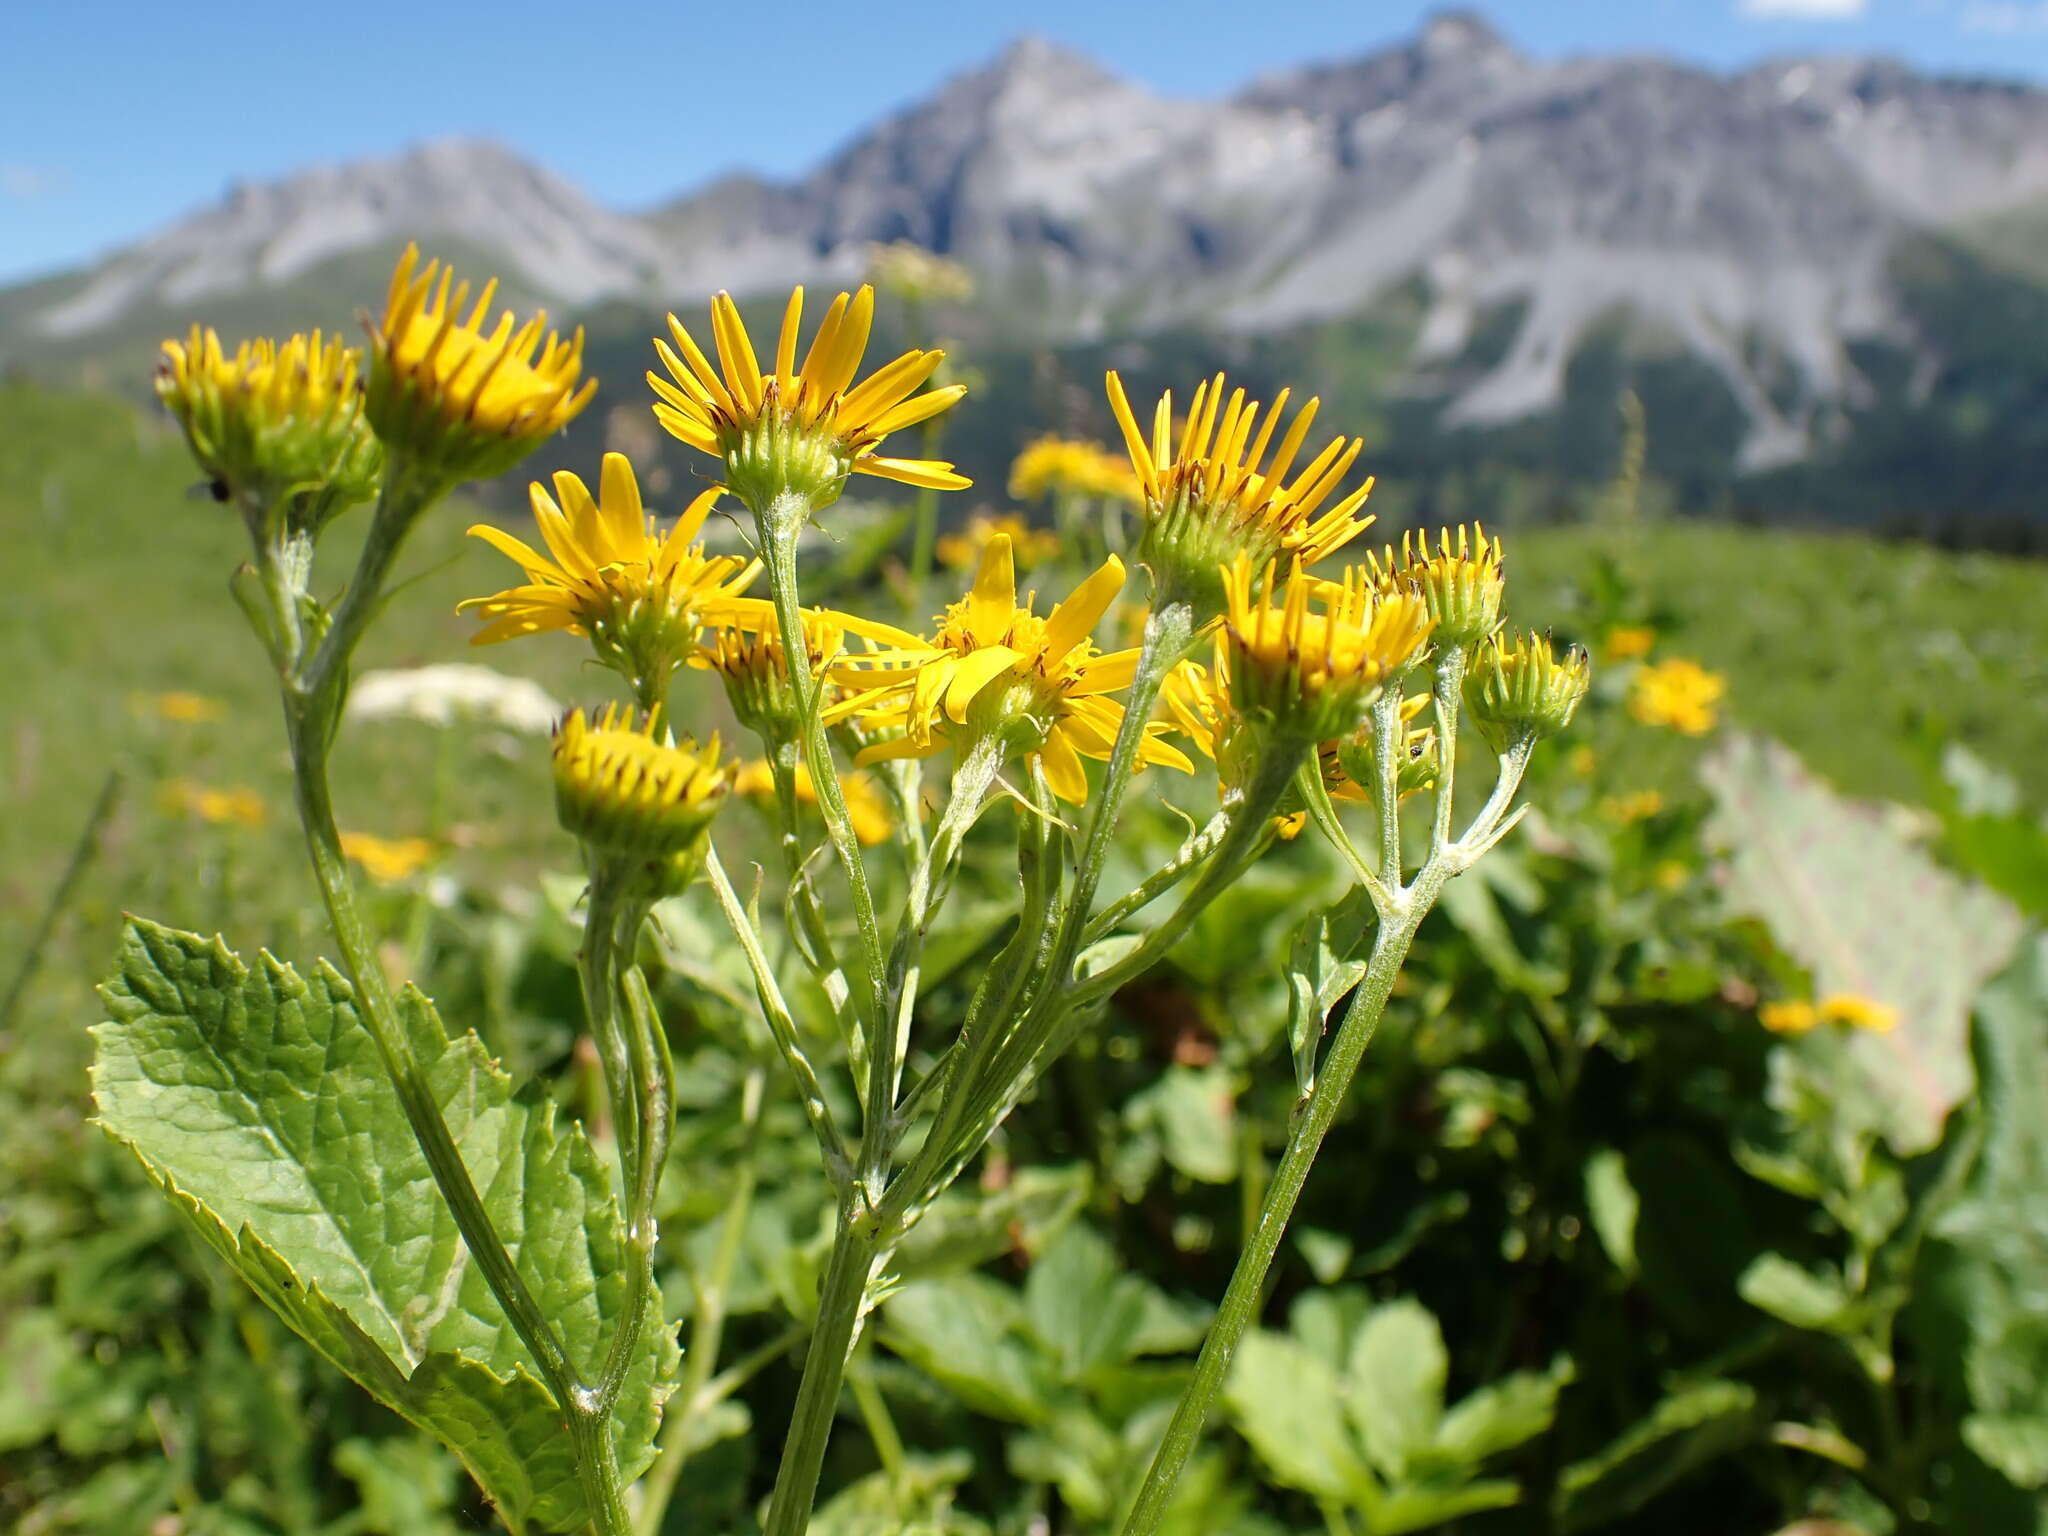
(0, 385, 2048, 1048)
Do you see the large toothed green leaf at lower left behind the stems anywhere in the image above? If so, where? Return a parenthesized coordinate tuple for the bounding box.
(92, 922, 676, 1532)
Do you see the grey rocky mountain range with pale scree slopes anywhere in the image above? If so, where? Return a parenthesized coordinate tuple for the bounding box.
(12, 12, 2048, 481)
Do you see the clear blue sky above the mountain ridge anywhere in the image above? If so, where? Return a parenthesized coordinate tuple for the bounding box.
(0, 0, 2048, 281)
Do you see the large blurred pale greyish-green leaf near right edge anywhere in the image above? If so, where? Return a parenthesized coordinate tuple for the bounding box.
(1700, 735, 2019, 1155)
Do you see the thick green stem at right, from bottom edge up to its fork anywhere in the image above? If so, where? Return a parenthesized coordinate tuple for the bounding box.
(1120, 884, 1446, 1536)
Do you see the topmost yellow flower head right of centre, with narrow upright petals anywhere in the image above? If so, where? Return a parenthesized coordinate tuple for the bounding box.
(1108, 371, 1372, 618)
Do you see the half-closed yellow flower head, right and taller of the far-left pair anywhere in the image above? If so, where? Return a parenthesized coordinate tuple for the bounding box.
(369, 246, 598, 481)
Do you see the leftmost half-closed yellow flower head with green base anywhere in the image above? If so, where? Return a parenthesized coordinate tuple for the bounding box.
(156, 326, 383, 532)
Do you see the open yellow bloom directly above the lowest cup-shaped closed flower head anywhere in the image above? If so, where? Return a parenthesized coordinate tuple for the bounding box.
(459, 453, 770, 688)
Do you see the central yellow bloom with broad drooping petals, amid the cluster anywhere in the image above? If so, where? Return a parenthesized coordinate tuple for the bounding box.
(827, 535, 1194, 805)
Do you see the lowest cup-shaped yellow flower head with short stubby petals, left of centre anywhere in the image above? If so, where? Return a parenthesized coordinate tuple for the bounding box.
(555, 705, 733, 866)
